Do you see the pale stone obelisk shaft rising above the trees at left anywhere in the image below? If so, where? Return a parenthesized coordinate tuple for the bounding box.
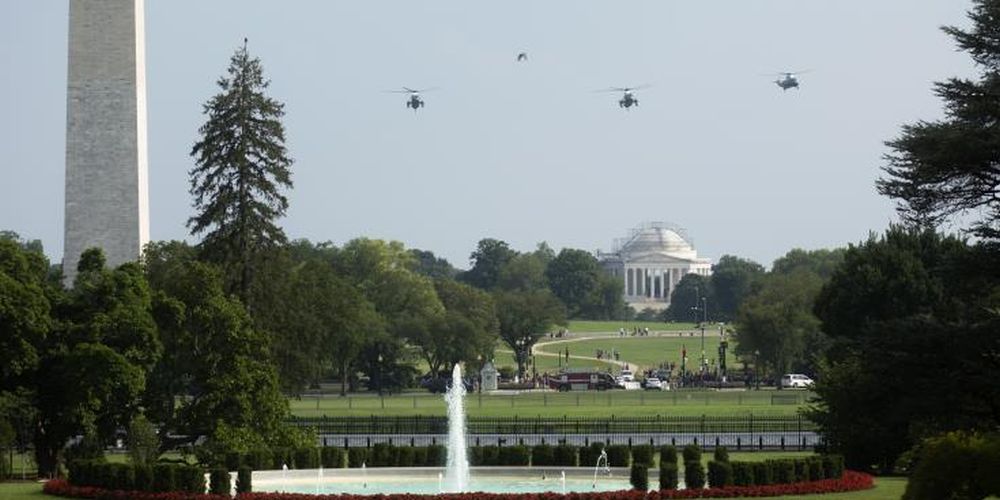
(63, 0, 149, 285)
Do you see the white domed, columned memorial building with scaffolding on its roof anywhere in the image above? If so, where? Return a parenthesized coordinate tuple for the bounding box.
(597, 222, 712, 310)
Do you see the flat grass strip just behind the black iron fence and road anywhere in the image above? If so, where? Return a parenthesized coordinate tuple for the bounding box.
(290, 390, 810, 417)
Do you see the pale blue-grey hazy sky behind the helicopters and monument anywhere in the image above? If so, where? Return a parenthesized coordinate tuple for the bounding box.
(0, 0, 975, 267)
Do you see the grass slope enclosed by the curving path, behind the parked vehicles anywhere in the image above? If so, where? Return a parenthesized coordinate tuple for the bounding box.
(535, 331, 737, 370)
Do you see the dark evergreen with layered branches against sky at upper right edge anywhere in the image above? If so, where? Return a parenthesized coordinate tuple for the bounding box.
(878, 0, 1000, 238)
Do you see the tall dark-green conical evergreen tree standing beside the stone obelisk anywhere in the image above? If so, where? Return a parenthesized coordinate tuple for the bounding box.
(188, 43, 292, 306)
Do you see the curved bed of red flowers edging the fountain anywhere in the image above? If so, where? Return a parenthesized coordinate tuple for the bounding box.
(44, 471, 875, 500)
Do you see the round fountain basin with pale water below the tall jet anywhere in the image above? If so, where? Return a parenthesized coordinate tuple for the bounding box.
(253, 466, 631, 495)
